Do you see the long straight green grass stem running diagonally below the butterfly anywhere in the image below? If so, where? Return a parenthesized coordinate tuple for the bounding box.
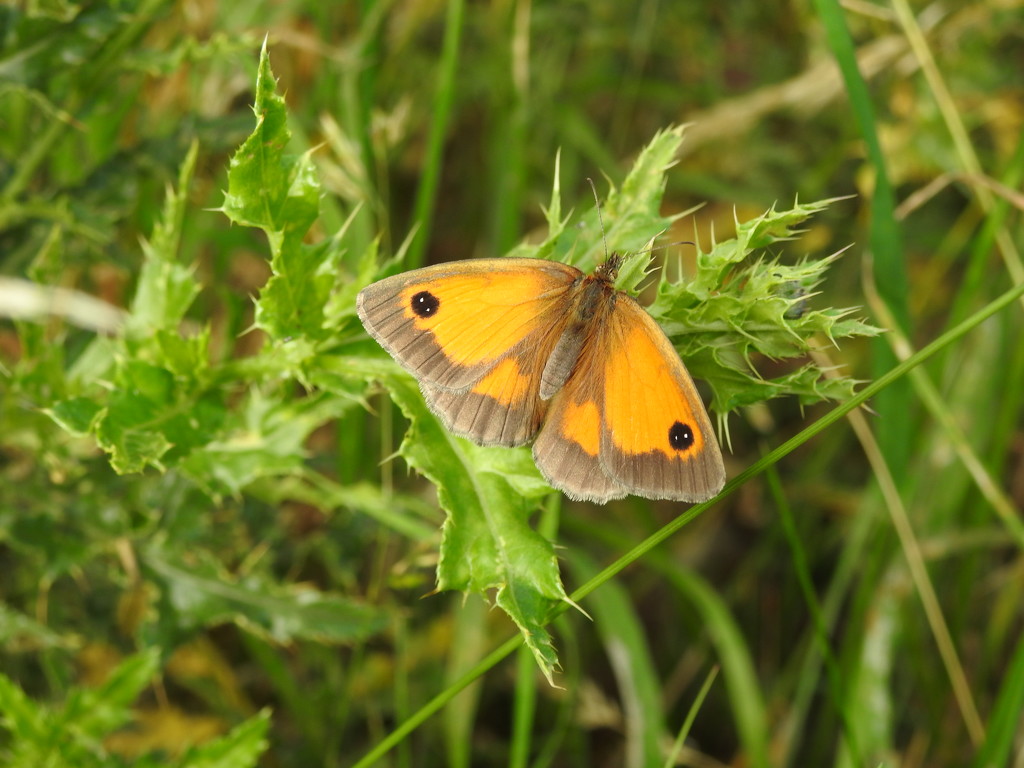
(353, 283, 1024, 768)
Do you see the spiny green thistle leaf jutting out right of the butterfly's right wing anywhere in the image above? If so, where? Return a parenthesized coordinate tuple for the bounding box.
(648, 195, 879, 417)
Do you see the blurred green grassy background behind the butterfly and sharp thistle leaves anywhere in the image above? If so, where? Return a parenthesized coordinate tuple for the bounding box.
(0, 0, 1024, 768)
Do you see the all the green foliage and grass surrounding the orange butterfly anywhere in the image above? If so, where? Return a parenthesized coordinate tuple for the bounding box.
(0, 0, 1024, 766)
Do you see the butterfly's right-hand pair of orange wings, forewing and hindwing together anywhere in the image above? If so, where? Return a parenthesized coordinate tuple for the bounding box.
(534, 288, 725, 503)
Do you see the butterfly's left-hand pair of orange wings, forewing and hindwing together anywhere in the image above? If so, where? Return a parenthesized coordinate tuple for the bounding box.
(357, 259, 582, 445)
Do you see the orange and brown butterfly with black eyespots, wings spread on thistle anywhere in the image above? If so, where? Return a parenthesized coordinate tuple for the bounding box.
(356, 254, 725, 503)
